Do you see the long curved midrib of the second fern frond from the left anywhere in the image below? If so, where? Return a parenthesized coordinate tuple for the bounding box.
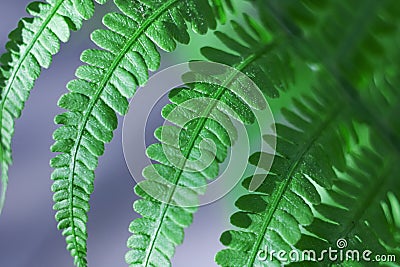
(64, 0, 179, 262)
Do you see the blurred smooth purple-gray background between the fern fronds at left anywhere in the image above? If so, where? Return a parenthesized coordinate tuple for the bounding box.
(0, 0, 232, 267)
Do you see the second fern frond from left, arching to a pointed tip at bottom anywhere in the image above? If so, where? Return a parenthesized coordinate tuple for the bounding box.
(51, 0, 231, 266)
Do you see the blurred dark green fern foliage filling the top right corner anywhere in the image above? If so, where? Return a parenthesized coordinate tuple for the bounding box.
(255, 0, 400, 155)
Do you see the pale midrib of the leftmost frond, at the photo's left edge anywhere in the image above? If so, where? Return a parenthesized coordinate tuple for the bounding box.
(0, 0, 64, 214)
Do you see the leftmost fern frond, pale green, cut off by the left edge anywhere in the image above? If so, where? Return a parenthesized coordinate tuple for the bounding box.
(0, 0, 105, 213)
